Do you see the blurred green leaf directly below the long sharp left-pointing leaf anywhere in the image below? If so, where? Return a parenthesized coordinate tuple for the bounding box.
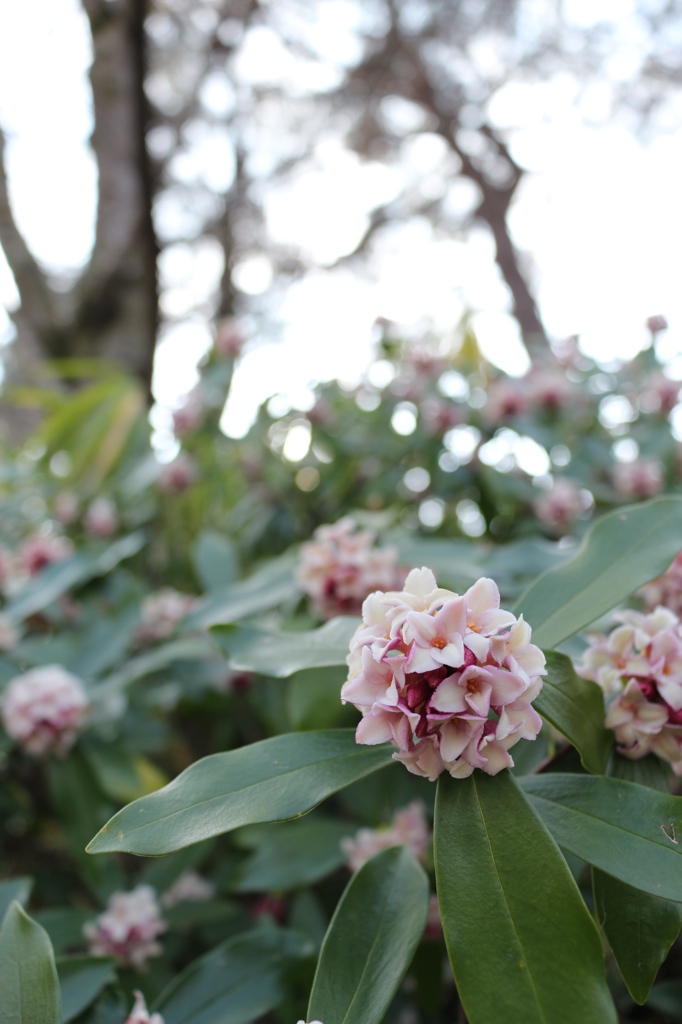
(233, 816, 353, 893)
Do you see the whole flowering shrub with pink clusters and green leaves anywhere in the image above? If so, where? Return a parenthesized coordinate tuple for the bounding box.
(0, 321, 682, 1024)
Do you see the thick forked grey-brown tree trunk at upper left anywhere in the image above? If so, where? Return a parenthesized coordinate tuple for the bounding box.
(0, 0, 158, 403)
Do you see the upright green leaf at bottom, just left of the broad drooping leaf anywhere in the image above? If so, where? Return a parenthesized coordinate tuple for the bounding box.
(308, 847, 429, 1024)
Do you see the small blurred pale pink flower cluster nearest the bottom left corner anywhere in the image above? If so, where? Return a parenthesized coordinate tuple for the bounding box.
(83, 886, 167, 971)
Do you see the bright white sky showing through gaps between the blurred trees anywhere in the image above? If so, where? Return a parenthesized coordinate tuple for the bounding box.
(0, 0, 682, 433)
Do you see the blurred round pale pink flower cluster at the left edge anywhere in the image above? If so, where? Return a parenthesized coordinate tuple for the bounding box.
(2, 665, 88, 755)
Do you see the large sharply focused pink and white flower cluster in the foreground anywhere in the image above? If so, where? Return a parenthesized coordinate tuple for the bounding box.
(341, 568, 545, 780)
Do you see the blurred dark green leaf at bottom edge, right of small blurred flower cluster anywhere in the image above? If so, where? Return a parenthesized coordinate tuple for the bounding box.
(154, 928, 312, 1024)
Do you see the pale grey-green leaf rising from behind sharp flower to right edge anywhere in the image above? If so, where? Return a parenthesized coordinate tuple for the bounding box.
(514, 497, 682, 647)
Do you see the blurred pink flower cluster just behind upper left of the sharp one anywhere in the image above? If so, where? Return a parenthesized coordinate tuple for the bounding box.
(298, 516, 401, 618)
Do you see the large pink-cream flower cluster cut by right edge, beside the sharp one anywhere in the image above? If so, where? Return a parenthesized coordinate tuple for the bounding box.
(581, 607, 682, 775)
